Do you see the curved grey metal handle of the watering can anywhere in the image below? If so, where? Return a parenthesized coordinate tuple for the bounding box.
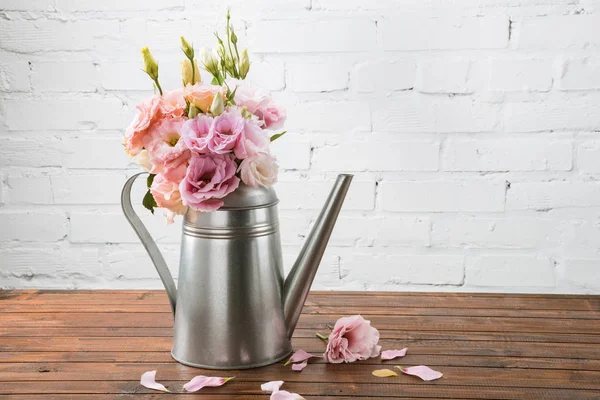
(121, 172, 177, 315)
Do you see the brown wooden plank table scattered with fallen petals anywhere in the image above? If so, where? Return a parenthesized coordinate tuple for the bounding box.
(0, 291, 600, 400)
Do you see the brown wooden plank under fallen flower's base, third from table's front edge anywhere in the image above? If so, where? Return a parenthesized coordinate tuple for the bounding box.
(0, 351, 600, 372)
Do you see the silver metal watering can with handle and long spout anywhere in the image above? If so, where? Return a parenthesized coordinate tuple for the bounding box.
(121, 173, 352, 369)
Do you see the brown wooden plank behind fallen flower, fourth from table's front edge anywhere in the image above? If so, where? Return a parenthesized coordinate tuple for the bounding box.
(0, 337, 600, 360)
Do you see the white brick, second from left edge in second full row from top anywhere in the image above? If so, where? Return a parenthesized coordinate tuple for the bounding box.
(31, 61, 100, 92)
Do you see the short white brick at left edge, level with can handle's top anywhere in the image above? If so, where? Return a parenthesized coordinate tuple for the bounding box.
(7, 176, 54, 204)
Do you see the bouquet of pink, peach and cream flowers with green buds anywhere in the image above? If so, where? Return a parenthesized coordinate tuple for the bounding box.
(124, 13, 286, 223)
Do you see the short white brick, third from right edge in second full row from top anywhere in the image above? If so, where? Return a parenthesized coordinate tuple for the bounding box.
(415, 59, 475, 93)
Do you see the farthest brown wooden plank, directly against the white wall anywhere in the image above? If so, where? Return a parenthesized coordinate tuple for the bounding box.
(0, 291, 600, 311)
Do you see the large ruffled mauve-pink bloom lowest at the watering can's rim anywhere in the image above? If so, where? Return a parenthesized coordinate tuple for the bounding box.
(179, 153, 240, 211)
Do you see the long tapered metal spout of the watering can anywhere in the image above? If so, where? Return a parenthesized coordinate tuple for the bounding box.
(283, 174, 352, 338)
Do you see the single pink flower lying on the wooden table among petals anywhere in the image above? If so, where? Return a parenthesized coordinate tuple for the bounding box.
(323, 315, 381, 364)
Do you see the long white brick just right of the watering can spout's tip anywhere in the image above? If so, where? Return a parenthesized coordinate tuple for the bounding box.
(380, 180, 505, 212)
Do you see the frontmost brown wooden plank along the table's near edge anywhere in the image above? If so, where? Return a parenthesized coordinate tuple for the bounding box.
(0, 379, 600, 400)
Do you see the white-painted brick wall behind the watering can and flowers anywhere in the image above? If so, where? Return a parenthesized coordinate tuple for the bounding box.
(0, 0, 600, 293)
